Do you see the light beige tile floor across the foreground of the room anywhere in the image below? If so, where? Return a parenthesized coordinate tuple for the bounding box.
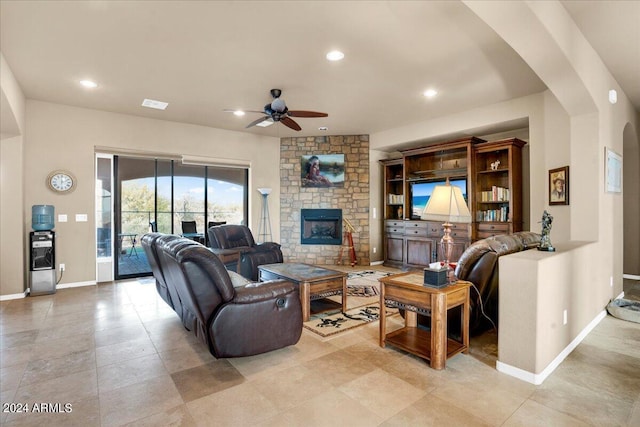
(0, 272, 640, 427)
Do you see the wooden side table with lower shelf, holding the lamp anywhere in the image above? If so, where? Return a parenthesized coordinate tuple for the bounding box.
(379, 273, 471, 369)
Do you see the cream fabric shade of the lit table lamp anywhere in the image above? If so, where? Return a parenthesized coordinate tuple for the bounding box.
(421, 184, 471, 222)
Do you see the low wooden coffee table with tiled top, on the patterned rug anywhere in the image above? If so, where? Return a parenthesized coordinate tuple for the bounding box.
(258, 263, 347, 322)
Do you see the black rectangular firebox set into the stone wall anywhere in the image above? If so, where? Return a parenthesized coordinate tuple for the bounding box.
(300, 209, 342, 245)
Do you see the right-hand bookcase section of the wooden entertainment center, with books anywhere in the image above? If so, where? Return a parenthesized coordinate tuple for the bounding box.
(472, 138, 526, 240)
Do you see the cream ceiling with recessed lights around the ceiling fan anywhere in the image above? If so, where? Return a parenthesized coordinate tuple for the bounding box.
(0, 1, 640, 143)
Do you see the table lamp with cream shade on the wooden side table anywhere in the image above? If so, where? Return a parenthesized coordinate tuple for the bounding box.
(421, 179, 471, 269)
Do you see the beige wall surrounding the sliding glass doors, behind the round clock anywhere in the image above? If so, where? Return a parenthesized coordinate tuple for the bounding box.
(20, 100, 280, 290)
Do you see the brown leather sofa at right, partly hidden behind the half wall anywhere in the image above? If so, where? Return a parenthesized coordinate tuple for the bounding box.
(450, 231, 540, 335)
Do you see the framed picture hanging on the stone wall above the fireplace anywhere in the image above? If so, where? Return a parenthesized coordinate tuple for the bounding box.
(300, 154, 344, 188)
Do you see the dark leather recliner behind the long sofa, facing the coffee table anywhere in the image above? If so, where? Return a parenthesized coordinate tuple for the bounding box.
(207, 224, 283, 281)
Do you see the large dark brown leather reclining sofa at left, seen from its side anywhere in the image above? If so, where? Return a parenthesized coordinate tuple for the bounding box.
(142, 233, 302, 358)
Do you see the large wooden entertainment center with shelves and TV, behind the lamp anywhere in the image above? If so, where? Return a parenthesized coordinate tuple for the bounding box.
(381, 137, 526, 268)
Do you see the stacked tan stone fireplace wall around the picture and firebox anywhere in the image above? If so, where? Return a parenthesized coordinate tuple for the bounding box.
(279, 135, 370, 265)
